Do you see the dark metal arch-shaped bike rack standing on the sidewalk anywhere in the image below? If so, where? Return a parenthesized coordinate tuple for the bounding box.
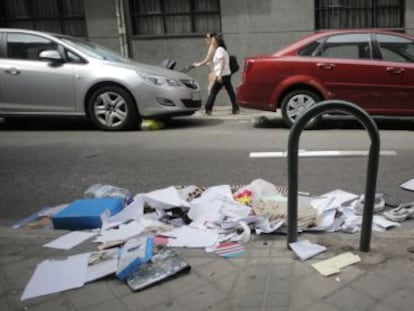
(287, 100, 380, 252)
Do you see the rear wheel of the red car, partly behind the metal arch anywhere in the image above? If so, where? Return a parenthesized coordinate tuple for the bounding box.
(281, 90, 321, 129)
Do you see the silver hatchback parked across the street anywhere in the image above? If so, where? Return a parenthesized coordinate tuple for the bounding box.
(0, 28, 201, 130)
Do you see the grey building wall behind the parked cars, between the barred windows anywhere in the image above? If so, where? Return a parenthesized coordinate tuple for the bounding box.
(84, 0, 414, 102)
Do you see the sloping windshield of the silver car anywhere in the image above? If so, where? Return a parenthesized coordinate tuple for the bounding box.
(58, 36, 129, 63)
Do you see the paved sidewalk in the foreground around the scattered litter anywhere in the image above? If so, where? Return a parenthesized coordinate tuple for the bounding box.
(0, 227, 414, 311)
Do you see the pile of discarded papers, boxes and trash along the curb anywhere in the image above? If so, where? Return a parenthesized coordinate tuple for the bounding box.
(14, 179, 414, 300)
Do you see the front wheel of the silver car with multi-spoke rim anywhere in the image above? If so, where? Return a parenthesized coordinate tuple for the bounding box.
(88, 86, 140, 131)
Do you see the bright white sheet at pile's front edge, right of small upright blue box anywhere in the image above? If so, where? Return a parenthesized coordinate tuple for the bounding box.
(163, 226, 219, 248)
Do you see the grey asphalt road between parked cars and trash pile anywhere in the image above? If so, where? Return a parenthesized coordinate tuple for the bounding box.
(0, 117, 414, 224)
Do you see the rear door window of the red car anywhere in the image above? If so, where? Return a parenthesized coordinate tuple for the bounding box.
(317, 33, 371, 59)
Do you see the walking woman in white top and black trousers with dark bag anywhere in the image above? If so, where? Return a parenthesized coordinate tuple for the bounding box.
(205, 34, 240, 115)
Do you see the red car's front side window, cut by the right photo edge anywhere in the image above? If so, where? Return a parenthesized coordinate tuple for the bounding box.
(377, 34, 414, 63)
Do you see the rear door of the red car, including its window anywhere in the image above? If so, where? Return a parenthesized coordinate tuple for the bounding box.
(313, 33, 384, 111)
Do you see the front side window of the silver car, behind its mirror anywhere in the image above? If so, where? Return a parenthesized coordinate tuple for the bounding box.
(6, 33, 57, 60)
